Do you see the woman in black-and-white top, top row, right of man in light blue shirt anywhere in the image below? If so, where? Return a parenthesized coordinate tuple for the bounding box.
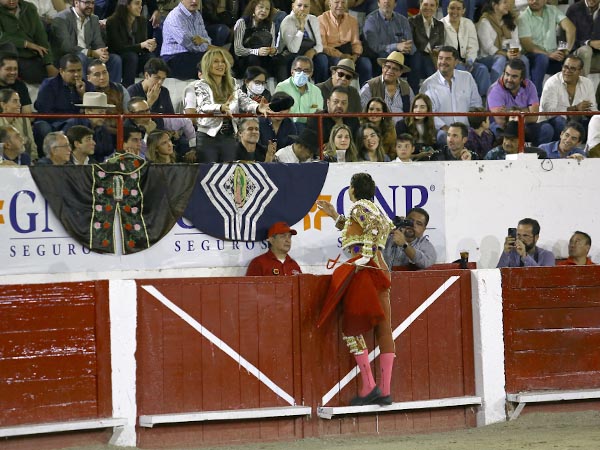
(233, 0, 278, 77)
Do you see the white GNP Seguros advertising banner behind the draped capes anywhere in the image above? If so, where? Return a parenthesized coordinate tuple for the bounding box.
(0, 163, 446, 275)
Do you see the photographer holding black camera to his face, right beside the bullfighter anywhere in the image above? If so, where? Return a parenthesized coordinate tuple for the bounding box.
(383, 207, 437, 270)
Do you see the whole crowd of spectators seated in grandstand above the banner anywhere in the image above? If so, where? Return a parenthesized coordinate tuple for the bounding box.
(0, 0, 600, 165)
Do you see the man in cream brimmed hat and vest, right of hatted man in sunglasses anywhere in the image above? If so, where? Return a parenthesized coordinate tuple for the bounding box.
(360, 51, 415, 123)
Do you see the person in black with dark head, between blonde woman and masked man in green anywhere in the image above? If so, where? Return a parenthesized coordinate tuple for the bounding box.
(258, 92, 298, 150)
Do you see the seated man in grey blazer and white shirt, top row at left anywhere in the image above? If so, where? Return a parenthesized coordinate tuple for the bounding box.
(50, 0, 123, 83)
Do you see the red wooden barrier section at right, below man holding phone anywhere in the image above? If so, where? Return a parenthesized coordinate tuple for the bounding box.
(502, 266, 600, 393)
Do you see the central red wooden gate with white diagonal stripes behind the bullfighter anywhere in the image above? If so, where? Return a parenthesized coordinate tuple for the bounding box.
(137, 270, 475, 447)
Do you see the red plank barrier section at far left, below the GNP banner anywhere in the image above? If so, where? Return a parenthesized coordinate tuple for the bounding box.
(0, 281, 112, 427)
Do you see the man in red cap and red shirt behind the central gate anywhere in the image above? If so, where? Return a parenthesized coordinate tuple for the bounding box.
(246, 222, 302, 277)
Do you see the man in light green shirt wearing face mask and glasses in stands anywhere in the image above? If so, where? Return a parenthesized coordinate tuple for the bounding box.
(275, 56, 323, 127)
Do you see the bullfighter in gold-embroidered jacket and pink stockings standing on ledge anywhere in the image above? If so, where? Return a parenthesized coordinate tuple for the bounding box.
(317, 173, 396, 406)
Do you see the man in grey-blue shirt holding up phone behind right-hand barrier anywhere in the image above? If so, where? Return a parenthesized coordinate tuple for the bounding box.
(496, 218, 554, 267)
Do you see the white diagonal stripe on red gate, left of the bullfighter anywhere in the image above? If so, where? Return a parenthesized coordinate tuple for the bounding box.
(142, 285, 296, 406)
